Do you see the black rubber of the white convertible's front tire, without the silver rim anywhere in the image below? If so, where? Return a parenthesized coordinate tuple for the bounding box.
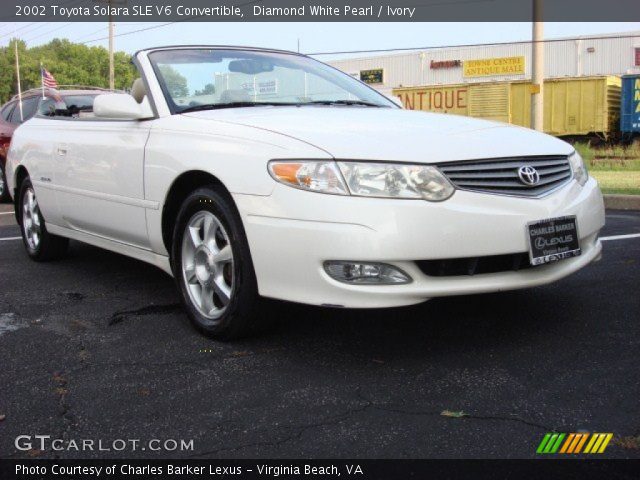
(171, 187, 258, 340)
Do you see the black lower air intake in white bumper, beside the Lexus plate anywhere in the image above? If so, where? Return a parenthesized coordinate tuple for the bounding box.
(416, 253, 531, 277)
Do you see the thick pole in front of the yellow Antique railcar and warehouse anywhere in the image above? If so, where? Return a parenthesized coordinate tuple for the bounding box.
(531, 0, 544, 132)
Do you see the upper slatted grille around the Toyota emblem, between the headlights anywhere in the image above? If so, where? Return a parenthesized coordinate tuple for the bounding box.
(438, 156, 571, 197)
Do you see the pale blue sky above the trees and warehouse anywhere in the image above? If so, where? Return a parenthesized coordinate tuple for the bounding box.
(0, 22, 640, 56)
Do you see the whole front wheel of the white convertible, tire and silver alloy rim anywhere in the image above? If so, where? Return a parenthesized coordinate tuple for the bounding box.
(171, 186, 262, 340)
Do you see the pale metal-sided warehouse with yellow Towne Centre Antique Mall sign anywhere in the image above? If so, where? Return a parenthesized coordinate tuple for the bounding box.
(329, 31, 640, 95)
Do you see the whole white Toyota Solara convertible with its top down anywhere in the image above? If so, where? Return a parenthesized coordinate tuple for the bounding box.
(7, 46, 604, 339)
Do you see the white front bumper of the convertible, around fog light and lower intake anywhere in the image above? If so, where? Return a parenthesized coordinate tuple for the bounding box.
(233, 179, 604, 308)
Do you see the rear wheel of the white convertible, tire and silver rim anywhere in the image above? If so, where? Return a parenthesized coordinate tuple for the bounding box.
(16, 178, 69, 262)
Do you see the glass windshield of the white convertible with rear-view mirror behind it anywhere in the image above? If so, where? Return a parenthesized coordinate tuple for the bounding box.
(149, 48, 395, 113)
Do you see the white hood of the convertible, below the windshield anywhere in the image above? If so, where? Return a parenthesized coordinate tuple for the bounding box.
(186, 106, 573, 163)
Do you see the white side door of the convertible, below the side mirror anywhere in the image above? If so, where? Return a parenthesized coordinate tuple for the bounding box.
(53, 118, 151, 248)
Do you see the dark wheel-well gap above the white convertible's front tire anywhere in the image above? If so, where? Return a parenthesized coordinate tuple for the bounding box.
(162, 170, 235, 252)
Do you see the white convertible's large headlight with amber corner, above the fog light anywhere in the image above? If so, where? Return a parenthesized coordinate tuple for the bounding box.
(269, 160, 454, 202)
